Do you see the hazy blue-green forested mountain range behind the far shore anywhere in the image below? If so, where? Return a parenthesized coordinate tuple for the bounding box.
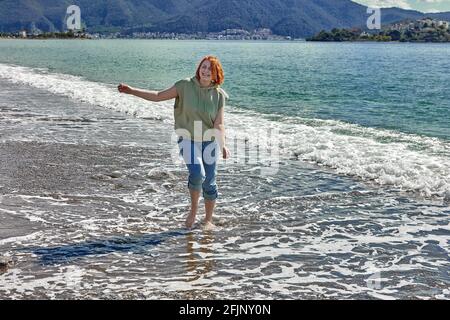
(0, 0, 450, 37)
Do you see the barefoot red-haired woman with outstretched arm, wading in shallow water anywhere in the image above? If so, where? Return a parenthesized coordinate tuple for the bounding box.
(118, 56, 230, 229)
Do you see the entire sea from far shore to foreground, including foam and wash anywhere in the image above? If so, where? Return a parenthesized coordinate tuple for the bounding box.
(0, 40, 450, 299)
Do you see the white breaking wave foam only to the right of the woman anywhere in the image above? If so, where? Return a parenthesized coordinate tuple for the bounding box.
(227, 110, 450, 198)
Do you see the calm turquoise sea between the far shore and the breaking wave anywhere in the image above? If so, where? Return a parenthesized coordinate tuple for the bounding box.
(0, 40, 450, 140)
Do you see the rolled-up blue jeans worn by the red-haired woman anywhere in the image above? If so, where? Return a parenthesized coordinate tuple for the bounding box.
(178, 137, 218, 200)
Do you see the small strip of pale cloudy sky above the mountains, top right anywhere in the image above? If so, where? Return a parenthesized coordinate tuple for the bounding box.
(353, 0, 450, 12)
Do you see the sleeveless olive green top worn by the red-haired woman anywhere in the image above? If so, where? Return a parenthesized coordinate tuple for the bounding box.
(174, 76, 228, 141)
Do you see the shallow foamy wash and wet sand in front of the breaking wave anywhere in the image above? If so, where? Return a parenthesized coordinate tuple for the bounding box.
(0, 70, 450, 299)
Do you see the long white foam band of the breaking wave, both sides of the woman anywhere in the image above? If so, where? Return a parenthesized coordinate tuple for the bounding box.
(0, 64, 450, 199)
